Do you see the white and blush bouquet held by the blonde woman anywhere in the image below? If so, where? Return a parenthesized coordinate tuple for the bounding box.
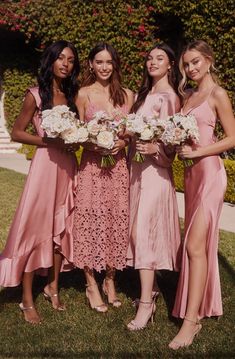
(161, 113, 199, 166)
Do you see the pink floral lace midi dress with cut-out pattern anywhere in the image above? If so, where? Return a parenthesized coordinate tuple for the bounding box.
(73, 102, 129, 271)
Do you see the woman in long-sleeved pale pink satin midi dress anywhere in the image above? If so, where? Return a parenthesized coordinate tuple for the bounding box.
(127, 44, 180, 331)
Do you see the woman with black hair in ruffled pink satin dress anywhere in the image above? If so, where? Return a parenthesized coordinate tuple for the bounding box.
(0, 40, 80, 324)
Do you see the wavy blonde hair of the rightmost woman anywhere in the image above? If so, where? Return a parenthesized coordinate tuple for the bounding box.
(178, 40, 218, 97)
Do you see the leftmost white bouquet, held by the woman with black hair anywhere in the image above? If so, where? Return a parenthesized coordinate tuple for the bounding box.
(41, 105, 88, 143)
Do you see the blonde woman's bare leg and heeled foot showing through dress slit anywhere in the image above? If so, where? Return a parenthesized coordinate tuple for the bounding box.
(170, 208, 207, 349)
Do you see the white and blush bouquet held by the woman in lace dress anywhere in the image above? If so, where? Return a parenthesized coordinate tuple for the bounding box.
(87, 111, 124, 167)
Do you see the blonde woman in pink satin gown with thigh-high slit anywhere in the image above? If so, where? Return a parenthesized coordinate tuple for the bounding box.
(169, 40, 235, 350)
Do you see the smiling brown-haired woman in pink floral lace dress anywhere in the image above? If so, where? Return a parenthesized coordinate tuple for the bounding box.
(73, 43, 133, 312)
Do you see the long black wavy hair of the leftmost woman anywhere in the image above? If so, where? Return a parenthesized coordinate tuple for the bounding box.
(38, 40, 80, 113)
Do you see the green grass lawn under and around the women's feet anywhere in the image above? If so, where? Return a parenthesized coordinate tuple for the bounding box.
(0, 168, 235, 359)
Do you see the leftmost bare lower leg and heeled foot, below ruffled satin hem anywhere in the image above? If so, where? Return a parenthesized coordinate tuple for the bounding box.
(20, 272, 41, 324)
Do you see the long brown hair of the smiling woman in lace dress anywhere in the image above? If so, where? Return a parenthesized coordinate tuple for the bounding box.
(82, 42, 126, 106)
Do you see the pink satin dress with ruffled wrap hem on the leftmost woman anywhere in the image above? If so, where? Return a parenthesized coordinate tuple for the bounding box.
(0, 87, 77, 287)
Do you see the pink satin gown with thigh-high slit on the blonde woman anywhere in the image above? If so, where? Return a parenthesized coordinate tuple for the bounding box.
(172, 91, 227, 318)
